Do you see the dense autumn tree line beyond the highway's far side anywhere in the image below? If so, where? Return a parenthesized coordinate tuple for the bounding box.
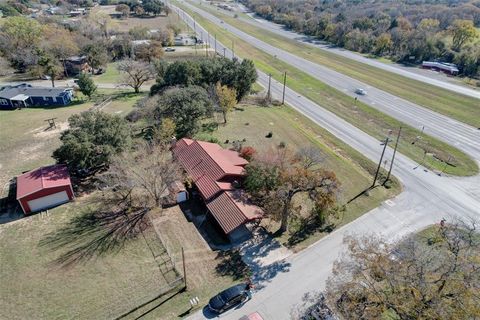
(243, 0, 480, 77)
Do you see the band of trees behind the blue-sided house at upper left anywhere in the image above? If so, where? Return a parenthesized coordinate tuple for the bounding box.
(0, 7, 180, 86)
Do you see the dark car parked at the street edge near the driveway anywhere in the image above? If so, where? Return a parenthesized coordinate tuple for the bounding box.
(208, 283, 250, 314)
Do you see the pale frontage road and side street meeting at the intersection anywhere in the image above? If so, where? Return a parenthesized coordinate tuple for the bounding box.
(170, 5, 480, 320)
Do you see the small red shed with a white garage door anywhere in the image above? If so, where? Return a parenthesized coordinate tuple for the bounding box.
(17, 165, 74, 214)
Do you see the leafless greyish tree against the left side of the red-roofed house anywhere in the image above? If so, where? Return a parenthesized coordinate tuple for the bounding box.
(101, 144, 181, 208)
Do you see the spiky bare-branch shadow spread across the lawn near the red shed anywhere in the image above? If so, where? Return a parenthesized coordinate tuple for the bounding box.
(39, 208, 148, 268)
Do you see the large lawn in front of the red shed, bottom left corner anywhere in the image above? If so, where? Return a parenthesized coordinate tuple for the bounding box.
(0, 196, 178, 319)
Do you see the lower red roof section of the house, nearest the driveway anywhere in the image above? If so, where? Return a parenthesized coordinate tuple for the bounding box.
(207, 190, 263, 234)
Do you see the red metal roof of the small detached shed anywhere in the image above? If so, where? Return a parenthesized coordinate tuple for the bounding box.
(17, 165, 71, 199)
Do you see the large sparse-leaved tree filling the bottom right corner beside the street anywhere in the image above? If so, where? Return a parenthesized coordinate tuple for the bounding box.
(326, 222, 480, 320)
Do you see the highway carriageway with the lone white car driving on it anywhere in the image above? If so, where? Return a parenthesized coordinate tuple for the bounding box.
(178, 1, 480, 159)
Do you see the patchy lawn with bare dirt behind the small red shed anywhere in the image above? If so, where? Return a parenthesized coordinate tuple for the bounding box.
(0, 89, 143, 190)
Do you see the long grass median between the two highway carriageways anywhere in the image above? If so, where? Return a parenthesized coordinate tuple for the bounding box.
(192, 3, 480, 127)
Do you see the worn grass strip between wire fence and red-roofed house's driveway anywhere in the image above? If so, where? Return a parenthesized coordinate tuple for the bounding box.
(124, 206, 244, 320)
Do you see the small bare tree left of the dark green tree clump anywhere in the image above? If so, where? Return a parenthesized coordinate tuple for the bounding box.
(117, 59, 155, 93)
